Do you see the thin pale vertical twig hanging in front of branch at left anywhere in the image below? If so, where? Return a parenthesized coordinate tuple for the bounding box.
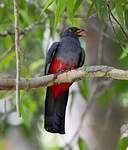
(13, 0, 21, 117)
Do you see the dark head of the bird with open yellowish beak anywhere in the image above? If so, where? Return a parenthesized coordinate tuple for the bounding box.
(62, 27, 86, 38)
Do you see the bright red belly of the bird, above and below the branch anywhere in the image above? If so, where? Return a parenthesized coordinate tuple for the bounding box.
(49, 59, 76, 97)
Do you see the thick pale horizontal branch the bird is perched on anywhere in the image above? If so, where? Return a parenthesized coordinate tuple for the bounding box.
(0, 66, 128, 90)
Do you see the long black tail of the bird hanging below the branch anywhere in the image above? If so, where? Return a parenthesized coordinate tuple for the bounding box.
(44, 87, 69, 134)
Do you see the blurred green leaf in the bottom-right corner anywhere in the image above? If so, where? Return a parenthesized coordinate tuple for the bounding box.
(117, 137, 128, 150)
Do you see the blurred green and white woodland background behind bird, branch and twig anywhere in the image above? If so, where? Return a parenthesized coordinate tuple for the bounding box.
(0, 0, 128, 150)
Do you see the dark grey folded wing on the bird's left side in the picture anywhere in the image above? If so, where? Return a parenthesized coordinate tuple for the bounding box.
(44, 42, 59, 75)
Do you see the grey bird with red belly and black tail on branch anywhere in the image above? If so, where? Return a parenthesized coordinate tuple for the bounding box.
(44, 27, 86, 134)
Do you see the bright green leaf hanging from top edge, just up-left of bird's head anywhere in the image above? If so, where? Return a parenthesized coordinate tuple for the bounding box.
(55, 0, 65, 26)
